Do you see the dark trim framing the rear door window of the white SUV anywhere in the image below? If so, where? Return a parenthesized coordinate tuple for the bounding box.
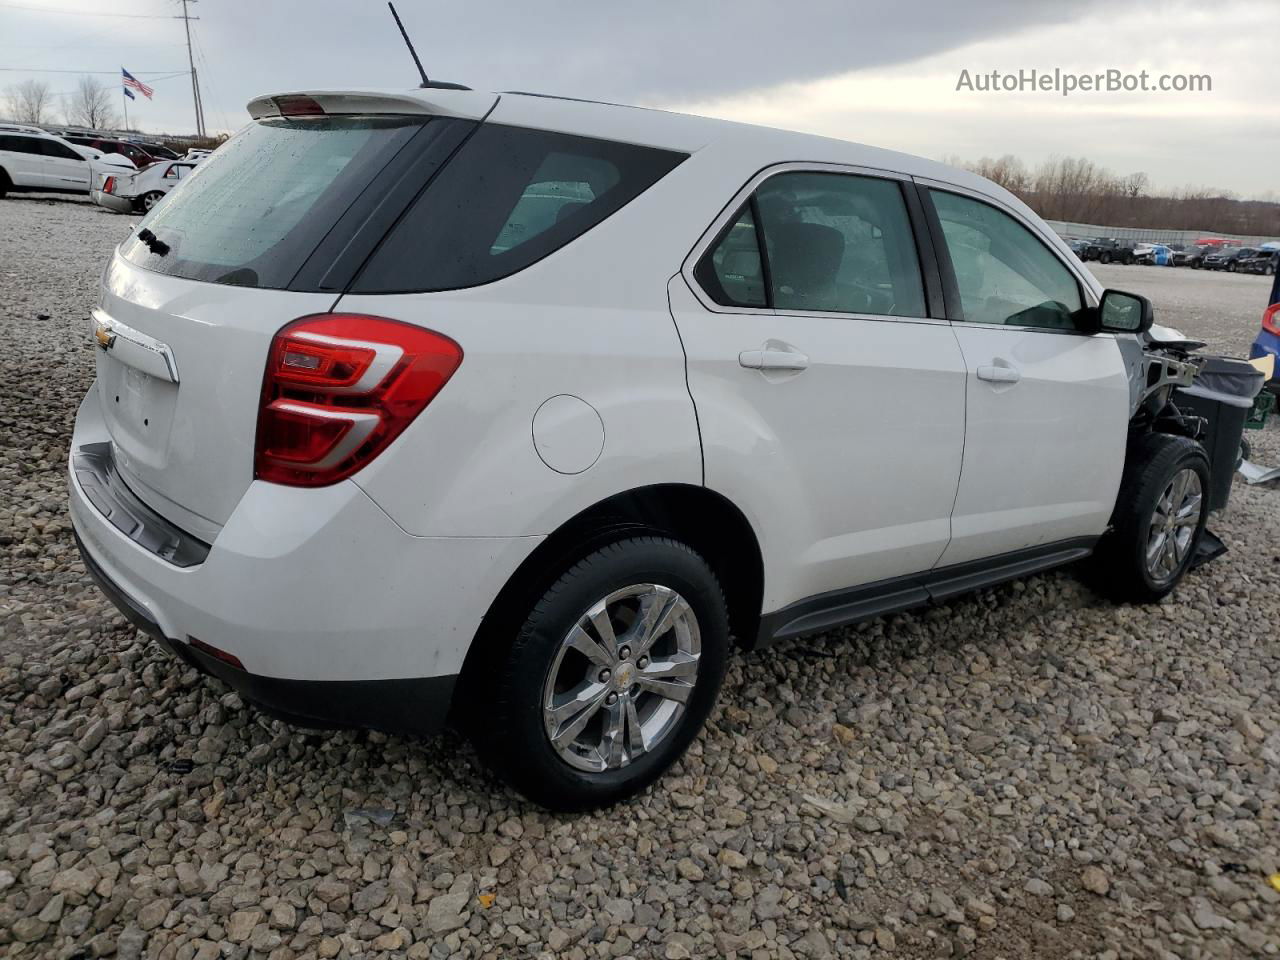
(680, 160, 947, 324)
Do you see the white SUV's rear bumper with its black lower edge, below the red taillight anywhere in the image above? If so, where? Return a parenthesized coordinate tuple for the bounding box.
(69, 385, 541, 732)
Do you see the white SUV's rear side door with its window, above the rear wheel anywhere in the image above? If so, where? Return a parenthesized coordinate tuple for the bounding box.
(669, 166, 965, 611)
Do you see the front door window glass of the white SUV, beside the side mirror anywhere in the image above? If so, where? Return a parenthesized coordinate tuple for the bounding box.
(929, 189, 1085, 330)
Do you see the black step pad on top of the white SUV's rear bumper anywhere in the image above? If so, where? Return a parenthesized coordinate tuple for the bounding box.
(72, 443, 210, 567)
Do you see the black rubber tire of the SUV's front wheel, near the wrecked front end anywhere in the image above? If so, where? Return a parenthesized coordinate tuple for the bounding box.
(1094, 434, 1210, 603)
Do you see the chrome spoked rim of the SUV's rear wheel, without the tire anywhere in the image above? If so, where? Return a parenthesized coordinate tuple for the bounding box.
(543, 584, 701, 773)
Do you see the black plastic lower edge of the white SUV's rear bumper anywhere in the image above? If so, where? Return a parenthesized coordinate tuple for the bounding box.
(76, 534, 458, 736)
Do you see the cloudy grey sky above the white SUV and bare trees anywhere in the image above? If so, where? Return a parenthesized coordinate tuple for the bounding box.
(0, 0, 1280, 198)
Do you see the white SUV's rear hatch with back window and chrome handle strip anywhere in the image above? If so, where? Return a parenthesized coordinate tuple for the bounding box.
(95, 95, 492, 541)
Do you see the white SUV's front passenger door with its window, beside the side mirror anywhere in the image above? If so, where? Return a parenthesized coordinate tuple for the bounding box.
(924, 188, 1129, 566)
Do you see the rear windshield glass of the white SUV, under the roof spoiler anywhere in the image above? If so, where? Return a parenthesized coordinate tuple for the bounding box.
(120, 116, 430, 289)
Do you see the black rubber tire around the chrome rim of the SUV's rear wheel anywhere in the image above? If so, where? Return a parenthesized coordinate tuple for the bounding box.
(467, 535, 728, 812)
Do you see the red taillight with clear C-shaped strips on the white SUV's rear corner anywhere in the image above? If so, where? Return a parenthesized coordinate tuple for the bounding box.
(253, 314, 462, 486)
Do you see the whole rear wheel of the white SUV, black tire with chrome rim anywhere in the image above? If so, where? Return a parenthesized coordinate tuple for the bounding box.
(468, 535, 728, 810)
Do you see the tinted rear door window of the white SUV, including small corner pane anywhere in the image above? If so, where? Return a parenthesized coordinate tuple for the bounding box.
(694, 173, 927, 317)
